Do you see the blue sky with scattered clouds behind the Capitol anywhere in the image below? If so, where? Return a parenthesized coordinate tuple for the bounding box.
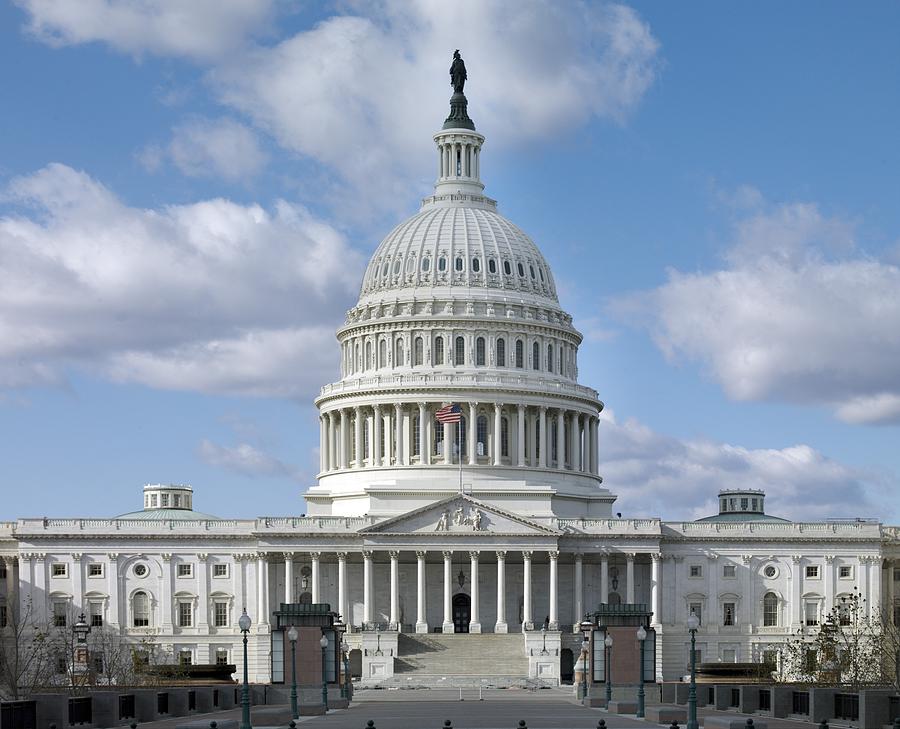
(0, 0, 900, 523)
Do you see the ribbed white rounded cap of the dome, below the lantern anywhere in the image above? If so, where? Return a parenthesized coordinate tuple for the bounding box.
(359, 203, 558, 305)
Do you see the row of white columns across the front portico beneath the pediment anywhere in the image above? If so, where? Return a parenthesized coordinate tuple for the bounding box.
(268, 544, 662, 633)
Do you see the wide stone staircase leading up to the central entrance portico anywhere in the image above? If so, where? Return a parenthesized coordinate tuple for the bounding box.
(389, 633, 528, 686)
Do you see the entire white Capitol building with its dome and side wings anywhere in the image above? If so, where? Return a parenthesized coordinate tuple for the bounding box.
(0, 61, 900, 683)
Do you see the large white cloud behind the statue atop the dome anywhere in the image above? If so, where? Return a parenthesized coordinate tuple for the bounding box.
(210, 0, 659, 213)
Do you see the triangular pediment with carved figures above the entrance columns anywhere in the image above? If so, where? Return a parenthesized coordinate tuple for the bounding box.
(360, 494, 559, 536)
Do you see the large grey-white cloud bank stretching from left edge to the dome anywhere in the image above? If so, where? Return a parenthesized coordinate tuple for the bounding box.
(0, 164, 363, 396)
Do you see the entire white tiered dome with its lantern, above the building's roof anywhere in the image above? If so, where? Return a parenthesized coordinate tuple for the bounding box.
(305, 61, 615, 519)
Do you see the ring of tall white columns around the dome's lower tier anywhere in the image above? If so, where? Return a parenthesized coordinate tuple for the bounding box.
(320, 399, 599, 476)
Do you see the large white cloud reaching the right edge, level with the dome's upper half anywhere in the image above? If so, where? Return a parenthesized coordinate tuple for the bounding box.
(614, 199, 900, 423)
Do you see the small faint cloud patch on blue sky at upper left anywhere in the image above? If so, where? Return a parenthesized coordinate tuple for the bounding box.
(168, 119, 266, 182)
